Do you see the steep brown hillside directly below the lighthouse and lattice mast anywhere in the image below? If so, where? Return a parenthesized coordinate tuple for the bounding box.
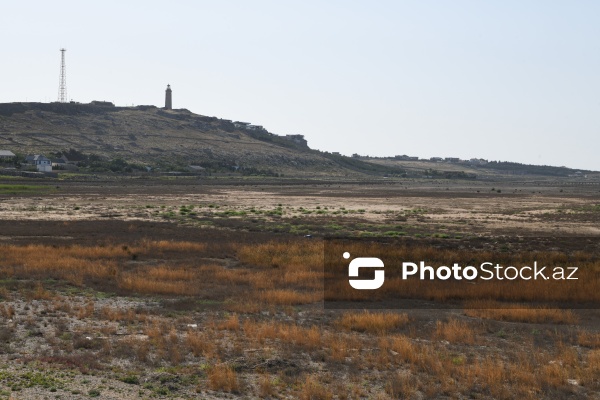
(0, 102, 380, 175)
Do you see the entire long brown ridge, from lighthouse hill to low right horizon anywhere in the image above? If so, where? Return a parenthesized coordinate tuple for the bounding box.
(0, 102, 598, 180)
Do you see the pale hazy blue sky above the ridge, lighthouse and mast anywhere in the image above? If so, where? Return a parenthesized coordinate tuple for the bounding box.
(0, 0, 600, 170)
